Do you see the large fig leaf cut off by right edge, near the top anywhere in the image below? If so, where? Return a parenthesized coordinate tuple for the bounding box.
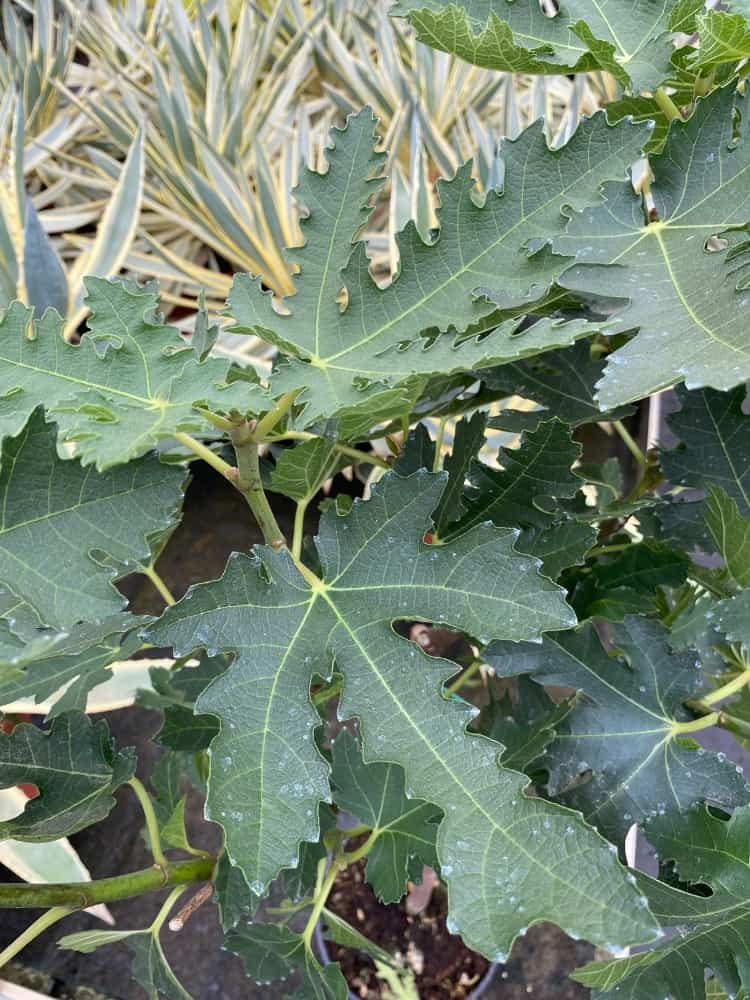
(554, 86, 750, 409)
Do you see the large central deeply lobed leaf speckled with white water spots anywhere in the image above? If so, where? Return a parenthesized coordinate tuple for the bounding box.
(149, 473, 652, 955)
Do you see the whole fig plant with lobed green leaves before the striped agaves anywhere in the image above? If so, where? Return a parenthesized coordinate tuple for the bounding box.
(0, 0, 750, 1000)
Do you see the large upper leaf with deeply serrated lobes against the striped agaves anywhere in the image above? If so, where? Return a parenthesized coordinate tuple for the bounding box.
(229, 110, 646, 426)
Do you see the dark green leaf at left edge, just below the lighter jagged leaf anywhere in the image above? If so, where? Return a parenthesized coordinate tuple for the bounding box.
(0, 412, 185, 628)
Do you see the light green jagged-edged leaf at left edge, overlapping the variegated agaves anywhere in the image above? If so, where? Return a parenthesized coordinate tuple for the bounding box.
(0, 278, 264, 472)
